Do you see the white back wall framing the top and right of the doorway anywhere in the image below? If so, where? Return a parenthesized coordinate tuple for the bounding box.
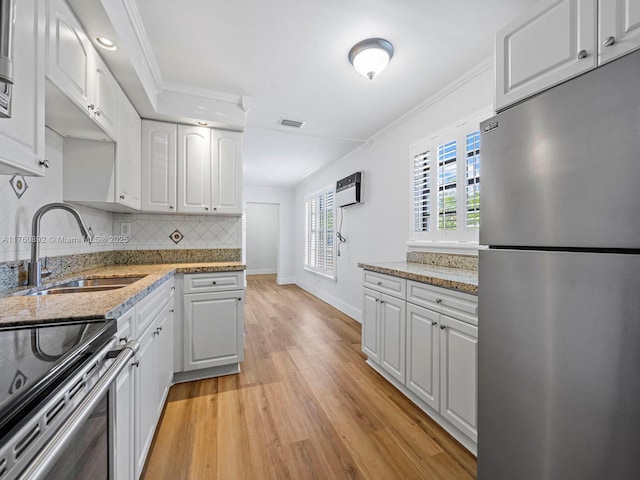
(243, 187, 297, 285)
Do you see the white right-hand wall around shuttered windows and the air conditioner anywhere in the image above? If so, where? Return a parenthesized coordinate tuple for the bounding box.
(294, 63, 493, 321)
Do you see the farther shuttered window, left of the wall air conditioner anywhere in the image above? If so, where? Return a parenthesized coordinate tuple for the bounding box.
(304, 189, 335, 278)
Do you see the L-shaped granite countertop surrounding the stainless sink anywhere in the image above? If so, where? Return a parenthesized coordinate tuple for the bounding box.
(0, 262, 246, 328)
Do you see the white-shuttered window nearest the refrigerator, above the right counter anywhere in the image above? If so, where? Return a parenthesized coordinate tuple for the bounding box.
(411, 111, 491, 241)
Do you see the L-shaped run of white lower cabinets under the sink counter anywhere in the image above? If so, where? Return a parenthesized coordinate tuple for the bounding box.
(114, 272, 244, 480)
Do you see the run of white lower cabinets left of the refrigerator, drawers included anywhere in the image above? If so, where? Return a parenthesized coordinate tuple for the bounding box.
(362, 271, 478, 452)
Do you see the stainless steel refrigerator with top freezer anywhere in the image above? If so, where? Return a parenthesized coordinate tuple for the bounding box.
(478, 47, 640, 480)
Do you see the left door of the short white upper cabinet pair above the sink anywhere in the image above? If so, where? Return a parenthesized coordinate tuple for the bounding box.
(47, 0, 96, 112)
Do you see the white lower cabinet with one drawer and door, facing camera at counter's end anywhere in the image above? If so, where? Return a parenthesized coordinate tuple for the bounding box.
(183, 272, 244, 372)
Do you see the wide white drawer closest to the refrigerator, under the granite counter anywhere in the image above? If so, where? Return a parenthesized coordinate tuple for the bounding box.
(407, 280, 478, 325)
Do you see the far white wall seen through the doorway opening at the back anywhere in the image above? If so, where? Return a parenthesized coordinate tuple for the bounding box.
(246, 202, 280, 275)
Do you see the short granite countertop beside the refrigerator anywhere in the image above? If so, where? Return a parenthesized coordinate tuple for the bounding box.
(358, 262, 478, 295)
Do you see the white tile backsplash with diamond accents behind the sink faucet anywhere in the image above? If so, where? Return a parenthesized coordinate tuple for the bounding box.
(0, 129, 242, 266)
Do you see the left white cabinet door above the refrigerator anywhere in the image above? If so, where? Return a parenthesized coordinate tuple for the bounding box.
(495, 0, 597, 110)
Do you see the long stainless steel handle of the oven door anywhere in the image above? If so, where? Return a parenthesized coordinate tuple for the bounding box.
(18, 340, 140, 480)
